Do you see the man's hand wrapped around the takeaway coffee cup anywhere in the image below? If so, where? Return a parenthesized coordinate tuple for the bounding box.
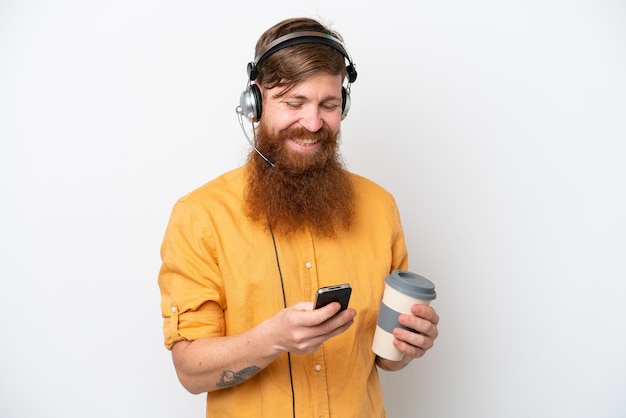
(393, 304, 439, 359)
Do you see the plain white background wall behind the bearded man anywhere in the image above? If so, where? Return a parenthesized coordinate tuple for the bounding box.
(0, 0, 626, 418)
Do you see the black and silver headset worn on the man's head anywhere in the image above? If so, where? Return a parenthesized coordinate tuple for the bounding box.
(237, 31, 357, 123)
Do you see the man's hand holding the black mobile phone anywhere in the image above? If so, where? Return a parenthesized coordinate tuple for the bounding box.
(267, 302, 356, 354)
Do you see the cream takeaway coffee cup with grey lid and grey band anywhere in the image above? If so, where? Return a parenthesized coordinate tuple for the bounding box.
(372, 270, 437, 361)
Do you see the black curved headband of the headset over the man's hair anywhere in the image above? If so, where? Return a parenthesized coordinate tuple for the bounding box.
(248, 31, 357, 83)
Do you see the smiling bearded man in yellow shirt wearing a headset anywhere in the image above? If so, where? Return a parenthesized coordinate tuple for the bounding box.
(159, 18, 439, 418)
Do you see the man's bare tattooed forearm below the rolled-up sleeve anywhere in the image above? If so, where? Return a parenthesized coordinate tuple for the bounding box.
(172, 327, 281, 394)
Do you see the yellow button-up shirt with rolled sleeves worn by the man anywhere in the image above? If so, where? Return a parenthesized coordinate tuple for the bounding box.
(159, 166, 408, 418)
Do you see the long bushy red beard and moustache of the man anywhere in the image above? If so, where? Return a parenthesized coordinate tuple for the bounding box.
(244, 123, 354, 237)
